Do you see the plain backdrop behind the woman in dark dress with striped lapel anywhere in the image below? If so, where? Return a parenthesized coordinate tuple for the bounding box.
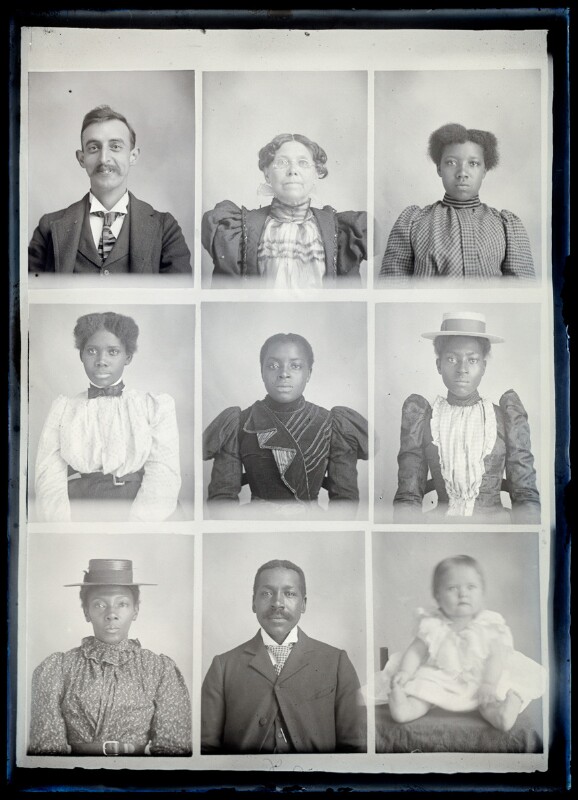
(201, 302, 367, 512)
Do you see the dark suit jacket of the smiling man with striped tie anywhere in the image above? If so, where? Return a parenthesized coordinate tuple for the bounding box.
(28, 192, 191, 274)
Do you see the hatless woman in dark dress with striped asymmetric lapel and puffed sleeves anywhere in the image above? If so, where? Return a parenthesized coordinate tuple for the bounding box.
(203, 333, 368, 511)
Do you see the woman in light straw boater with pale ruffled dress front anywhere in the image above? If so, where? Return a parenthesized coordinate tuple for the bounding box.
(393, 311, 540, 524)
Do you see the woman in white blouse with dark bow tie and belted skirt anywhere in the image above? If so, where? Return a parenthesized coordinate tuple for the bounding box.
(36, 311, 181, 522)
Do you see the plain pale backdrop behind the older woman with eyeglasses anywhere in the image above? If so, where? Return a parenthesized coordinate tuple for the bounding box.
(201, 72, 367, 286)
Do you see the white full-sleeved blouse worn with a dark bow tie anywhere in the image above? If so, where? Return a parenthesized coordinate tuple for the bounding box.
(36, 389, 181, 522)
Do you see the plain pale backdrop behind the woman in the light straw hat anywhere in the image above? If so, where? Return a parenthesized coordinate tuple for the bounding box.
(375, 302, 541, 522)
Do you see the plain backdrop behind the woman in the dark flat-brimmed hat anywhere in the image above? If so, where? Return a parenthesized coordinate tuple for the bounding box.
(26, 533, 194, 708)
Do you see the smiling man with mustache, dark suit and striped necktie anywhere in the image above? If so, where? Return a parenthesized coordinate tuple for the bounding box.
(28, 105, 191, 276)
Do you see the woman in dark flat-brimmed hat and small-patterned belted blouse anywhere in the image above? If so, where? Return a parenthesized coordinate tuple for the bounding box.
(28, 558, 191, 756)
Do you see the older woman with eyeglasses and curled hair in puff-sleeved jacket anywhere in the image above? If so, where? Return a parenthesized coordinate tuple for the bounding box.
(202, 133, 367, 290)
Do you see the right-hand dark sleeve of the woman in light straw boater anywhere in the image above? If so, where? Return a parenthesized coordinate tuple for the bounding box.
(500, 389, 540, 524)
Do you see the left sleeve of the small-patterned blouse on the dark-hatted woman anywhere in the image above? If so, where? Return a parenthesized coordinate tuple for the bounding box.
(28, 653, 70, 756)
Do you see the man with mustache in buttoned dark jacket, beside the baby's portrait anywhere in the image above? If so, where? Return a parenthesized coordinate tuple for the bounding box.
(201, 560, 366, 755)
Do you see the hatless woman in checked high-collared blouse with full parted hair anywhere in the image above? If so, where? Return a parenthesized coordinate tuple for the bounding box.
(380, 124, 535, 280)
